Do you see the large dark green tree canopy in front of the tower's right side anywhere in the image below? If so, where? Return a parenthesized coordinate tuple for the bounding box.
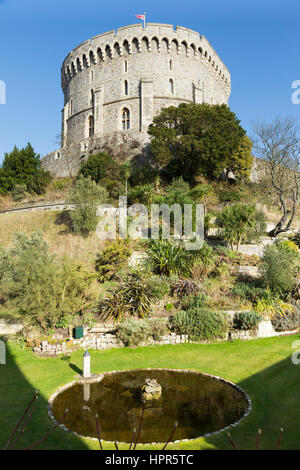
(148, 103, 252, 181)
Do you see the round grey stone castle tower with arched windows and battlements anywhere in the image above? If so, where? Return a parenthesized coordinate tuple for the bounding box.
(42, 23, 231, 176)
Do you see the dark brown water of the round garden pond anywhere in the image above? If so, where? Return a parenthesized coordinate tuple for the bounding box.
(51, 369, 250, 443)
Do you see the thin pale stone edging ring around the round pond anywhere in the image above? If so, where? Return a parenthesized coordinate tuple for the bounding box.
(47, 367, 252, 445)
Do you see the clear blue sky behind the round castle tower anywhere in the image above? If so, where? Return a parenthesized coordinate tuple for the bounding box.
(0, 0, 300, 160)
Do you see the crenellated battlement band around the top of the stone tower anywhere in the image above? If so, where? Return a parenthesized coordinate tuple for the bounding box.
(62, 23, 230, 95)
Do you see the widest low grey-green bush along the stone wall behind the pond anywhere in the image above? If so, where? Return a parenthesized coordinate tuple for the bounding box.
(171, 308, 229, 341)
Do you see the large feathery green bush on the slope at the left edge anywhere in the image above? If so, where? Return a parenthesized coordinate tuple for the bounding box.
(0, 232, 94, 330)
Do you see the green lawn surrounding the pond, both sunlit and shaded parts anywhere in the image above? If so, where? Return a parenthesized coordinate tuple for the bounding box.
(0, 335, 300, 450)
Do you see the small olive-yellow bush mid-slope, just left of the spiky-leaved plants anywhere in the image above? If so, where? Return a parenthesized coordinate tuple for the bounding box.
(96, 240, 132, 282)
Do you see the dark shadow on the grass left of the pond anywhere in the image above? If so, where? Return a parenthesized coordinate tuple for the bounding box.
(0, 346, 86, 450)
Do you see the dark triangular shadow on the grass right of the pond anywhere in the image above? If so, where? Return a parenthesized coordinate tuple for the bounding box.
(207, 350, 300, 450)
